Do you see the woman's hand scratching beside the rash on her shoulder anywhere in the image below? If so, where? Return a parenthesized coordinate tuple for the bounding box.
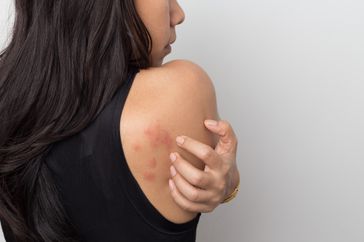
(169, 120, 240, 213)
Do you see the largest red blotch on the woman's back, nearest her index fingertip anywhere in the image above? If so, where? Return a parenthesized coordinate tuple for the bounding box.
(144, 124, 173, 150)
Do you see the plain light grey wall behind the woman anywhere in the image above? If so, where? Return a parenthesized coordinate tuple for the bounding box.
(0, 0, 364, 242)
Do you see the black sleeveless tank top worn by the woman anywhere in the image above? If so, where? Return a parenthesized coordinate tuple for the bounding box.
(3, 68, 201, 242)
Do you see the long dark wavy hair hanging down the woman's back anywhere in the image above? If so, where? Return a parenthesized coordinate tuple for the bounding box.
(0, 0, 152, 242)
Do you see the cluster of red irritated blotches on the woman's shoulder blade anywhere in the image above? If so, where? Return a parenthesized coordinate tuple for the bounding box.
(133, 124, 173, 182)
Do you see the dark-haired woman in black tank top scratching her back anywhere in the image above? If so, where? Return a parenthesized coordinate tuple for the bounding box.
(0, 0, 239, 241)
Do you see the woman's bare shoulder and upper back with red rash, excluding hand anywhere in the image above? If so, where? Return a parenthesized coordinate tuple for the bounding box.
(120, 60, 219, 223)
